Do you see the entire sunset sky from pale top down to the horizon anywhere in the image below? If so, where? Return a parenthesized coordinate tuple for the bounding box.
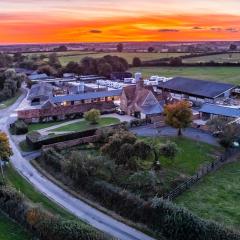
(0, 0, 240, 44)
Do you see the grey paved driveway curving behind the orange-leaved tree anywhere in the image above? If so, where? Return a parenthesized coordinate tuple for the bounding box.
(131, 125, 219, 146)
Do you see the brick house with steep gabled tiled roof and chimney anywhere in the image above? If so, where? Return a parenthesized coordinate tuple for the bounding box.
(120, 79, 163, 119)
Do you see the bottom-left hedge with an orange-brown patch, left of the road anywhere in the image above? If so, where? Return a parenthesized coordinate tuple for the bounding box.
(0, 186, 109, 240)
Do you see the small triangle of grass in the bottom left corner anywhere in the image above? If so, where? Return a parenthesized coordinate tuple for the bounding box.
(0, 211, 32, 240)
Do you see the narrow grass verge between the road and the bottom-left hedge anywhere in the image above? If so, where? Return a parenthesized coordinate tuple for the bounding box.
(4, 165, 76, 220)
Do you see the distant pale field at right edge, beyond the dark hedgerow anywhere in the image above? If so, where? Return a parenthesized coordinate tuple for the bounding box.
(183, 53, 240, 63)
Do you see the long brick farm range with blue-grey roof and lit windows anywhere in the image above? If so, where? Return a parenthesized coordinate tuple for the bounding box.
(17, 90, 121, 122)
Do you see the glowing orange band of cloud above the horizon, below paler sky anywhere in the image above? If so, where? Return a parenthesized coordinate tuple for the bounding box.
(0, 13, 240, 43)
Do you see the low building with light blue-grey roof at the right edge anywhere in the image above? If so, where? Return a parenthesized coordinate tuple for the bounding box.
(199, 103, 240, 120)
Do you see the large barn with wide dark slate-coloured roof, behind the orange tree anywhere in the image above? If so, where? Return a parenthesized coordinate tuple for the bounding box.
(158, 77, 236, 103)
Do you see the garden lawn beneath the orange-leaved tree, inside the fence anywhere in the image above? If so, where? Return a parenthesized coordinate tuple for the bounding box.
(142, 137, 220, 175)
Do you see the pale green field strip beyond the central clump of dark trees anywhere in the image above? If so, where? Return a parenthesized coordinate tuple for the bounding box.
(59, 52, 187, 65)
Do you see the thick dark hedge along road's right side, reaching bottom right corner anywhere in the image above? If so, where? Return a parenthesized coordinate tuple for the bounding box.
(84, 181, 240, 240)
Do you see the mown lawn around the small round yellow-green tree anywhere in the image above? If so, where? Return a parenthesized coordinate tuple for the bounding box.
(51, 117, 120, 132)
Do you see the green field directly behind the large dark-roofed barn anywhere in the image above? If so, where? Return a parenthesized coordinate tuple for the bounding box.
(130, 67, 240, 85)
